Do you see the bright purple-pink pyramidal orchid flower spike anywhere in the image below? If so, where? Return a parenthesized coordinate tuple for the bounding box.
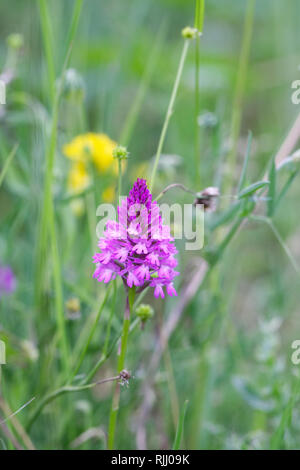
(93, 179, 179, 298)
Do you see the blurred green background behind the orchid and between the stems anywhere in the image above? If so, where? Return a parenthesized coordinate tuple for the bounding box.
(0, 0, 300, 449)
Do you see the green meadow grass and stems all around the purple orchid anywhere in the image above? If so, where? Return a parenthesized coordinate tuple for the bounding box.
(0, 0, 300, 450)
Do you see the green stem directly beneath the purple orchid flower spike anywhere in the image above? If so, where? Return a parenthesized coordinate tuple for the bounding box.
(108, 288, 135, 450)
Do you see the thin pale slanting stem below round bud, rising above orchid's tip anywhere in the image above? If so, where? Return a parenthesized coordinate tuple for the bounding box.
(149, 39, 190, 192)
